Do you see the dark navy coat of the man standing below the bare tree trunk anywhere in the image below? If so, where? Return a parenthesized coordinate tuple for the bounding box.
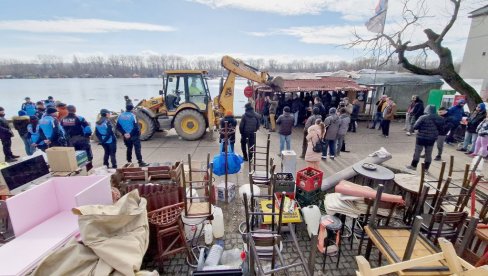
(413, 105, 443, 141)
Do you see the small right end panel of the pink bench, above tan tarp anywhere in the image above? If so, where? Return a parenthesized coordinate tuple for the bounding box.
(75, 176, 113, 206)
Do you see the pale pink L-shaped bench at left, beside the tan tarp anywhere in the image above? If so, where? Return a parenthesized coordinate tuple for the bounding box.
(0, 176, 112, 275)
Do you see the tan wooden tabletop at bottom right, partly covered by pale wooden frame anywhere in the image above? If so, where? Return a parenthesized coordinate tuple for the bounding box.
(365, 226, 451, 275)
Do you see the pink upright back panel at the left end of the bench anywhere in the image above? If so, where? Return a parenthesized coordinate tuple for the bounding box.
(7, 179, 59, 237)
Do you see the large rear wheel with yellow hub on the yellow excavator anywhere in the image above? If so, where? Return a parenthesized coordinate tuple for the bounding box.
(174, 109, 207, 141)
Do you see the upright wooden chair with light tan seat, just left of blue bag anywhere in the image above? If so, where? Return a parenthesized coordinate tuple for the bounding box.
(181, 154, 213, 218)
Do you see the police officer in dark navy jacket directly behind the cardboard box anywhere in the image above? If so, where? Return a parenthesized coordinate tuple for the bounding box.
(61, 105, 93, 161)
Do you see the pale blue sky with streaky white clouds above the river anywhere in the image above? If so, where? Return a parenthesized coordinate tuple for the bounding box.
(0, 0, 480, 61)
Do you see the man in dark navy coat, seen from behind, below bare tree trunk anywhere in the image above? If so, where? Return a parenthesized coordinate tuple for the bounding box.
(407, 105, 444, 171)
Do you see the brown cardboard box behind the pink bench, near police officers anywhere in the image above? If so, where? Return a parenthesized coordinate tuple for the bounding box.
(46, 147, 78, 172)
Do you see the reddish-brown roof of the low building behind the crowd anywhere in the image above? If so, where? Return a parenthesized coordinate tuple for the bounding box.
(257, 77, 368, 92)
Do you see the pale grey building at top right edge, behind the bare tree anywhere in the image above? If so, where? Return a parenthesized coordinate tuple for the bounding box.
(460, 5, 488, 100)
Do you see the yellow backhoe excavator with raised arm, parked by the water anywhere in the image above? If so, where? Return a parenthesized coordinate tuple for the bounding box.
(134, 56, 283, 141)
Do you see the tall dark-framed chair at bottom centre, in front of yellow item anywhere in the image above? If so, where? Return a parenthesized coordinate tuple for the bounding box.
(243, 193, 311, 275)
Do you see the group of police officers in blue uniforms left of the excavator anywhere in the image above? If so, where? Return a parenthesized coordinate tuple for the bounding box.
(0, 96, 148, 168)
